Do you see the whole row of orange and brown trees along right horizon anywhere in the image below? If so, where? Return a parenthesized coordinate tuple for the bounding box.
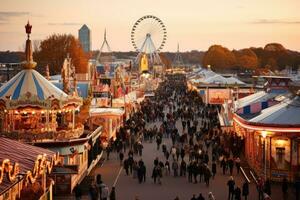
(202, 43, 300, 70)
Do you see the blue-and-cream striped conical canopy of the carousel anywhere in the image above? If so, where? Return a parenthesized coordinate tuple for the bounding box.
(0, 69, 68, 100)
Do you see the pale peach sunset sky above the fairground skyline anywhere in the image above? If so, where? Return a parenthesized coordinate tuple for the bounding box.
(0, 0, 300, 51)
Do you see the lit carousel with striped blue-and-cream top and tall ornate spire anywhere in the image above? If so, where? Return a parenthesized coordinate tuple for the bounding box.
(0, 23, 83, 141)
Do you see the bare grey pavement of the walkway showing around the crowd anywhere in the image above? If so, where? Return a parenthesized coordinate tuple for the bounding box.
(60, 96, 292, 200)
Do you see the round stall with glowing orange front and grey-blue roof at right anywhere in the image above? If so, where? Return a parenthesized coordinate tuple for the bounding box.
(233, 93, 300, 181)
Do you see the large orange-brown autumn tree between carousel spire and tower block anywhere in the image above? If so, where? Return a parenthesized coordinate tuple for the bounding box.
(34, 34, 88, 74)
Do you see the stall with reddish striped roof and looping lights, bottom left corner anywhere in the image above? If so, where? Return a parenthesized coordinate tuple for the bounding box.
(0, 137, 59, 200)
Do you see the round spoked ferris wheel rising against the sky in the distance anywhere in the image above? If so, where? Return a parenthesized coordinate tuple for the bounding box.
(131, 15, 167, 54)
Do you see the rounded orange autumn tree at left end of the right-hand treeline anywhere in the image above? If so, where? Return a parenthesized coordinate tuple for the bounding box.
(202, 45, 236, 70)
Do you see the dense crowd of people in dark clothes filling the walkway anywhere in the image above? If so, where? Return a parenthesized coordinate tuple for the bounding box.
(74, 76, 296, 200)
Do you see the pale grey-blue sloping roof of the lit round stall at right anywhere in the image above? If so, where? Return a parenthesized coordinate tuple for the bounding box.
(249, 96, 300, 125)
